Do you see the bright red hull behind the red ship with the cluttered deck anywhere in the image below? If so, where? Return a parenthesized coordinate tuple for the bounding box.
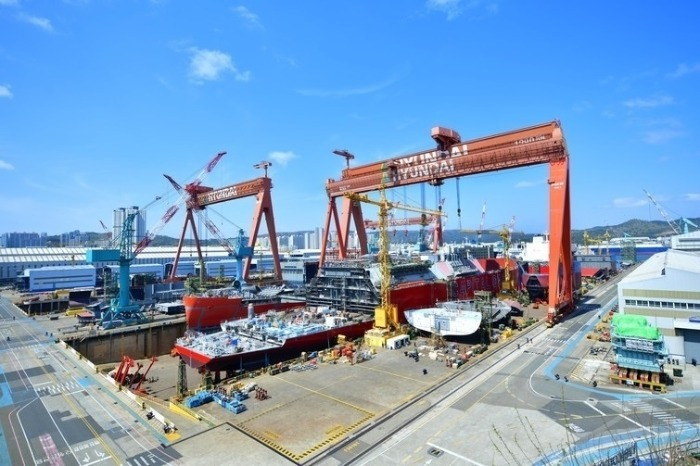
(182, 295, 299, 330)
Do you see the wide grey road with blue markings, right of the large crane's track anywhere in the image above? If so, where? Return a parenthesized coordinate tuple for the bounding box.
(309, 272, 700, 466)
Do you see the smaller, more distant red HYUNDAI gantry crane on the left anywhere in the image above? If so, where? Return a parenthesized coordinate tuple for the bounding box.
(164, 157, 282, 280)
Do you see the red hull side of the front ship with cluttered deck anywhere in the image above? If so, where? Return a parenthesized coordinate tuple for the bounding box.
(175, 318, 374, 371)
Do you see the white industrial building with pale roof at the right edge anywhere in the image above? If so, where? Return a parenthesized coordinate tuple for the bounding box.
(617, 249, 700, 365)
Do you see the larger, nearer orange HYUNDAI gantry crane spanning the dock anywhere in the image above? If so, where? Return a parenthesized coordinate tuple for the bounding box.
(319, 121, 573, 324)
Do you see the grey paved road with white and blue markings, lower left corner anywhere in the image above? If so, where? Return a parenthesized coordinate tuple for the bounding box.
(0, 298, 184, 466)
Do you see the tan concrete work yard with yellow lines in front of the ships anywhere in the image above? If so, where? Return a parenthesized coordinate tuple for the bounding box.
(134, 302, 544, 465)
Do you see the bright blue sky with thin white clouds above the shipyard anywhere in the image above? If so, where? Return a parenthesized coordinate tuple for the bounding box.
(0, 0, 700, 240)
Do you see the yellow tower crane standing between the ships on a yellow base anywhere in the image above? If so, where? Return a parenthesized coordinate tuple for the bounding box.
(344, 189, 445, 336)
